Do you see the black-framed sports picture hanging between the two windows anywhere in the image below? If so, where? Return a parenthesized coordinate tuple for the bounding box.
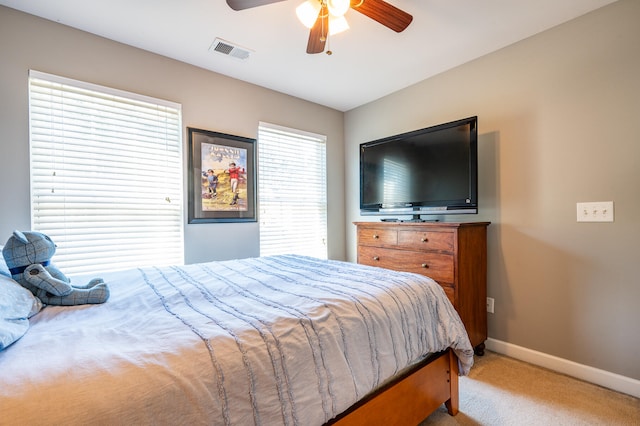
(187, 127, 257, 223)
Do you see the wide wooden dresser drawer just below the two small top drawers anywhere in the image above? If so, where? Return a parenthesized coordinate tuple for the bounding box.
(358, 246, 454, 285)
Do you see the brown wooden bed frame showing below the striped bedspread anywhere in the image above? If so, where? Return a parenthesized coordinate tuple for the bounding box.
(327, 349, 459, 426)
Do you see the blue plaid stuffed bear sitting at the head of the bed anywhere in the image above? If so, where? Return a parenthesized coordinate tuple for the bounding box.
(2, 231, 109, 306)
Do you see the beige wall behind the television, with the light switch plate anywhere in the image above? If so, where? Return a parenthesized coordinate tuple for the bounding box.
(345, 0, 640, 379)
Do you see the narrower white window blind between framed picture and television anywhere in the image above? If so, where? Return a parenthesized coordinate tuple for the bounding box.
(258, 123, 327, 259)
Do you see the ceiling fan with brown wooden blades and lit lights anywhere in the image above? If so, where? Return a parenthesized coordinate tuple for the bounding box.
(227, 0, 413, 55)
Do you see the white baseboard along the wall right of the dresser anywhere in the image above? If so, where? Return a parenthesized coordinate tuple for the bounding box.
(485, 338, 640, 398)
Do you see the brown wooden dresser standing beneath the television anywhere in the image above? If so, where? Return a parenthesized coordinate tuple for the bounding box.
(355, 222, 490, 355)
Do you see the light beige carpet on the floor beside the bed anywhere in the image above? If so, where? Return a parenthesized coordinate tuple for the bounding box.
(420, 351, 640, 426)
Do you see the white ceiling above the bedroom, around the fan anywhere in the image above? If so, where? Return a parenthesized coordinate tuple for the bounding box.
(0, 0, 615, 111)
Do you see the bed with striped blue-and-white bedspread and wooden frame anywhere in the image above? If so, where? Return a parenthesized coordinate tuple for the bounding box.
(0, 255, 473, 425)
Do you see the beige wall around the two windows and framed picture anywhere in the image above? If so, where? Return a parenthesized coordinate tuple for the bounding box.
(0, 6, 345, 263)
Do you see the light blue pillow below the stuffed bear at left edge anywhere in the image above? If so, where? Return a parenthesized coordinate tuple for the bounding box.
(0, 274, 42, 351)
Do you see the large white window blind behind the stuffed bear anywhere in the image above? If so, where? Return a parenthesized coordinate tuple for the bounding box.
(29, 71, 184, 275)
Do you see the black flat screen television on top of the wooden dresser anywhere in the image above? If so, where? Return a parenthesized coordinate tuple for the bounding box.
(360, 117, 478, 220)
